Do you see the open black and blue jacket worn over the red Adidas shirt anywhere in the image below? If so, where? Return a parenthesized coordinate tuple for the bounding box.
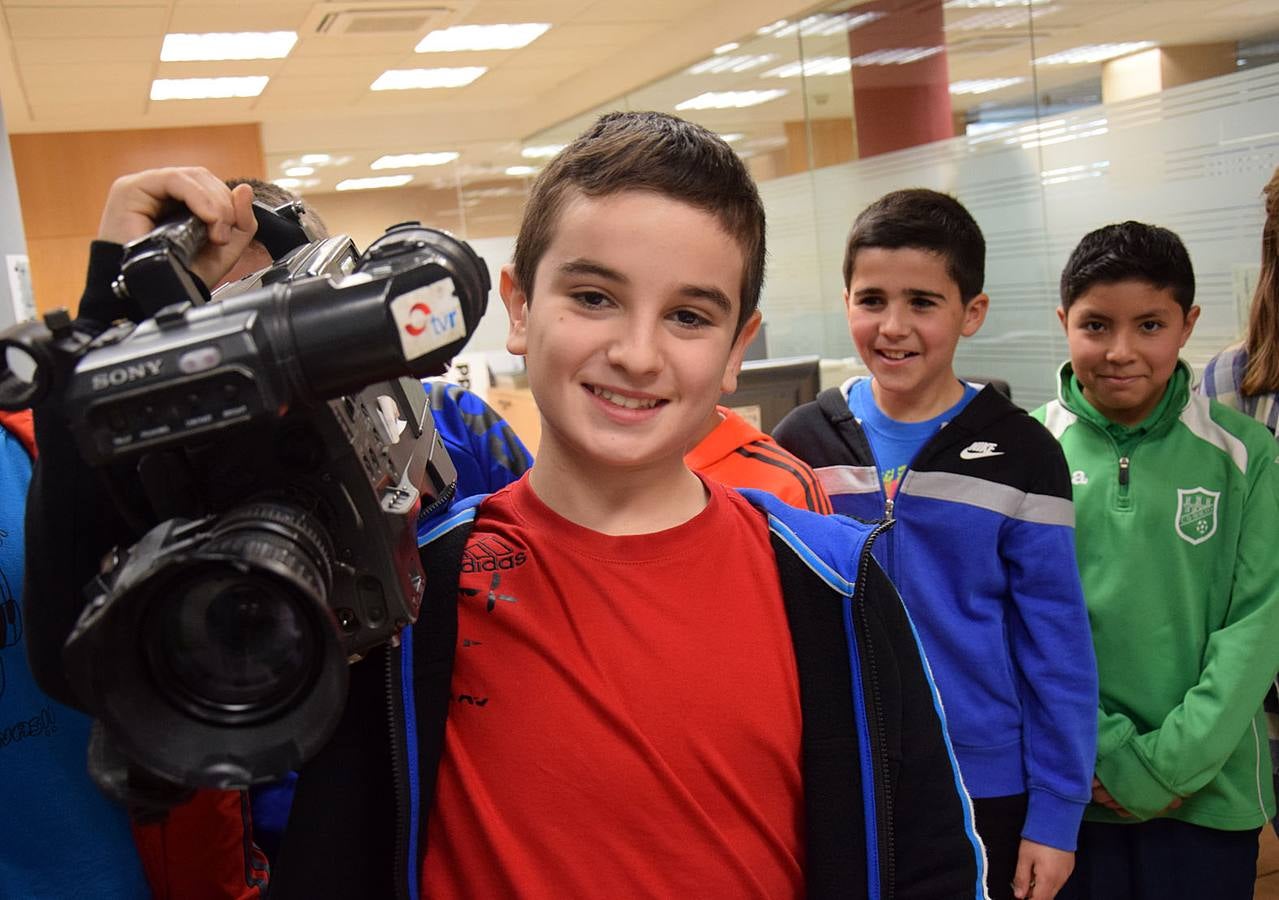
(259, 491, 985, 900)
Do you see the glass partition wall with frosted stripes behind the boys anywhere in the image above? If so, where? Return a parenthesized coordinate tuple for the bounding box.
(506, 0, 1279, 408)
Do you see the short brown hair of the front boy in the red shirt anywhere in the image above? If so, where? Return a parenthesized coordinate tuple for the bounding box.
(514, 113, 765, 331)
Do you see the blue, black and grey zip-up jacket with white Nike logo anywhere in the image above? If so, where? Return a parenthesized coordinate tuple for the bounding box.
(774, 380, 1097, 850)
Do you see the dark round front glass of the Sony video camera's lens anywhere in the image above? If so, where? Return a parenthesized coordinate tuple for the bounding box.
(147, 566, 317, 718)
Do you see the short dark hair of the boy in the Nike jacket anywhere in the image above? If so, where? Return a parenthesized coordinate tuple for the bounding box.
(844, 188, 986, 304)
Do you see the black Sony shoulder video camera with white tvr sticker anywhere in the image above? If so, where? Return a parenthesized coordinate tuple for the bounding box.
(0, 212, 490, 788)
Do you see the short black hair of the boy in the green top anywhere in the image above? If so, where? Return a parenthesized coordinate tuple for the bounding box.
(1062, 221, 1195, 312)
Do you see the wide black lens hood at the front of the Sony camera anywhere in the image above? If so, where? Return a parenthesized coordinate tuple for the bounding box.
(63, 519, 349, 789)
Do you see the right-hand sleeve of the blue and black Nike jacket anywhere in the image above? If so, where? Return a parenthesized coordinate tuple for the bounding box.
(999, 442, 1097, 850)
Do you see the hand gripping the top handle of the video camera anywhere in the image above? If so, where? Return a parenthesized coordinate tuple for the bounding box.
(97, 166, 257, 285)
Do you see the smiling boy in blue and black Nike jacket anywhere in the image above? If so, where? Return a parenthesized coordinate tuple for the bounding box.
(774, 189, 1097, 900)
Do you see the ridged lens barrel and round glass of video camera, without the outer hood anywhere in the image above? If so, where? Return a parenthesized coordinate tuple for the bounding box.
(142, 501, 333, 724)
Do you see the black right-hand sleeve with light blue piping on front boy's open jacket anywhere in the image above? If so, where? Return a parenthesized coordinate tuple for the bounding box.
(861, 561, 986, 900)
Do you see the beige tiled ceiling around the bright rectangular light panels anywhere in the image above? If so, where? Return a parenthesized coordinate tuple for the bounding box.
(0, 0, 1279, 192)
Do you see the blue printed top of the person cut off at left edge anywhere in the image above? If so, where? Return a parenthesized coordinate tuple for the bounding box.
(0, 428, 151, 900)
